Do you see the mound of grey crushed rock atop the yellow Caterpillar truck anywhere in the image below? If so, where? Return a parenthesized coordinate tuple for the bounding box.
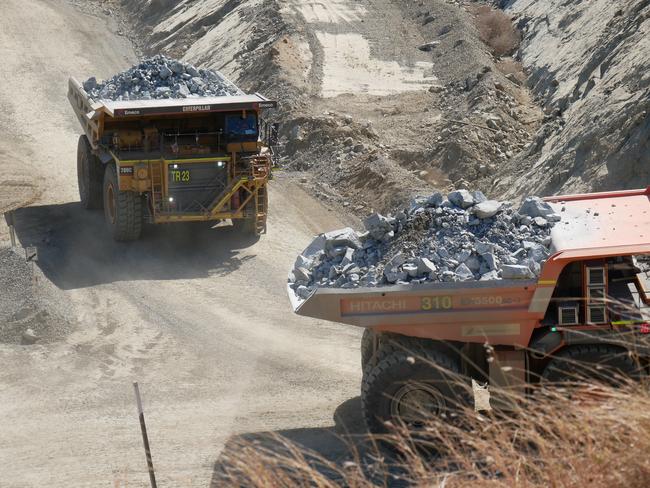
(83, 54, 243, 101)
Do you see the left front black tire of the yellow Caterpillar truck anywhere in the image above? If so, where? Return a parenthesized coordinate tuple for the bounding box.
(103, 164, 142, 241)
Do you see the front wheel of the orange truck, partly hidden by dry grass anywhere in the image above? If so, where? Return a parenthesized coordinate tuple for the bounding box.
(542, 344, 641, 386)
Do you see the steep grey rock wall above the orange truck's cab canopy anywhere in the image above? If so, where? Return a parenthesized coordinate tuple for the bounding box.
(494, 0, 650, 197)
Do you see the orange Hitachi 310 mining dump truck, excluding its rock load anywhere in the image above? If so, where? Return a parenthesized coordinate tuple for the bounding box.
(288, 187, 650, 433)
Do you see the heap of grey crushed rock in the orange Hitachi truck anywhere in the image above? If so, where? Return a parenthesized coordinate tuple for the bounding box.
(289, 190, 561, 298)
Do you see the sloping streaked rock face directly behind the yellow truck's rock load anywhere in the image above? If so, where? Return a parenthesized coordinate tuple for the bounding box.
(121, 0, 294, 102)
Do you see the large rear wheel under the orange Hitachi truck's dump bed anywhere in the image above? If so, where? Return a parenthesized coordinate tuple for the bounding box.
(361, 349, 467, 434)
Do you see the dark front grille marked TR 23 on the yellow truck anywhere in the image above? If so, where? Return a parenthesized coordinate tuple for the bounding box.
(167, 161, 228, 213)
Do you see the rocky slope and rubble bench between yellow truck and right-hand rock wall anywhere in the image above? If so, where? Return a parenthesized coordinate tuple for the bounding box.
(109, 0, 544, 214)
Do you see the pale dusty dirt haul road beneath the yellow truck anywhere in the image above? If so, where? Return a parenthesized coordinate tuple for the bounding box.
(0, 0, 360, 487)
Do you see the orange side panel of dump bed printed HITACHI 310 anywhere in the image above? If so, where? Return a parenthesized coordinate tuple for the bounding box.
(289, 280, 543, 344)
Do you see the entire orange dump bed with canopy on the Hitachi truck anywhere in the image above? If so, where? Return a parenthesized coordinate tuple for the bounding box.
(288, 188, 650, 347)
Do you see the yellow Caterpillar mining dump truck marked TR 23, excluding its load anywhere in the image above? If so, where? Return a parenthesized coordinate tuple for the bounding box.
(68, 78, 277, 241)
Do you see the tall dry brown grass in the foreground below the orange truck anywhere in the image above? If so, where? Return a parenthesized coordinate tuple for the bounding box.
(215, 383, 650, 488)
